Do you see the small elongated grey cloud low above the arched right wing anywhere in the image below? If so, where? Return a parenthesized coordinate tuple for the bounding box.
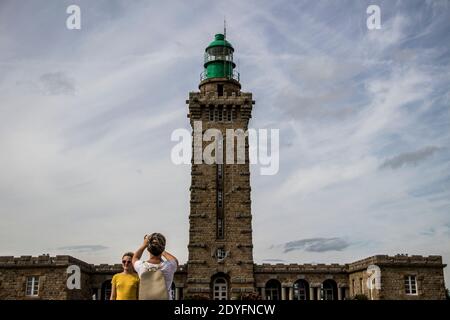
(284, 238, 350, 253)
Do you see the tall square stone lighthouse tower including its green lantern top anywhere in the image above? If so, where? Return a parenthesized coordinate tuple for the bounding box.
(186, 34, 255, 299)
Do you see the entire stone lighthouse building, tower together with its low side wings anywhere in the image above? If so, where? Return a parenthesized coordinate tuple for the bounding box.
(0, 34, 446, 300)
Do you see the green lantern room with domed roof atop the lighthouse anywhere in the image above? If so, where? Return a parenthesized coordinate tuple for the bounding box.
(200, 33, 239, 81)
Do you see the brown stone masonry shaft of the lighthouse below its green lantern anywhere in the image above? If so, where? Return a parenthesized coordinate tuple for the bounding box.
(187, 81, 254, 298)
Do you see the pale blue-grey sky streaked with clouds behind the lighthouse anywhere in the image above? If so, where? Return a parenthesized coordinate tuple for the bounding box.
(0, 0, 450, 288)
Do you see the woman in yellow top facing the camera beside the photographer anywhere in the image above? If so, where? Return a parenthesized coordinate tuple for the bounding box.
(110, 252, 139, 300)
